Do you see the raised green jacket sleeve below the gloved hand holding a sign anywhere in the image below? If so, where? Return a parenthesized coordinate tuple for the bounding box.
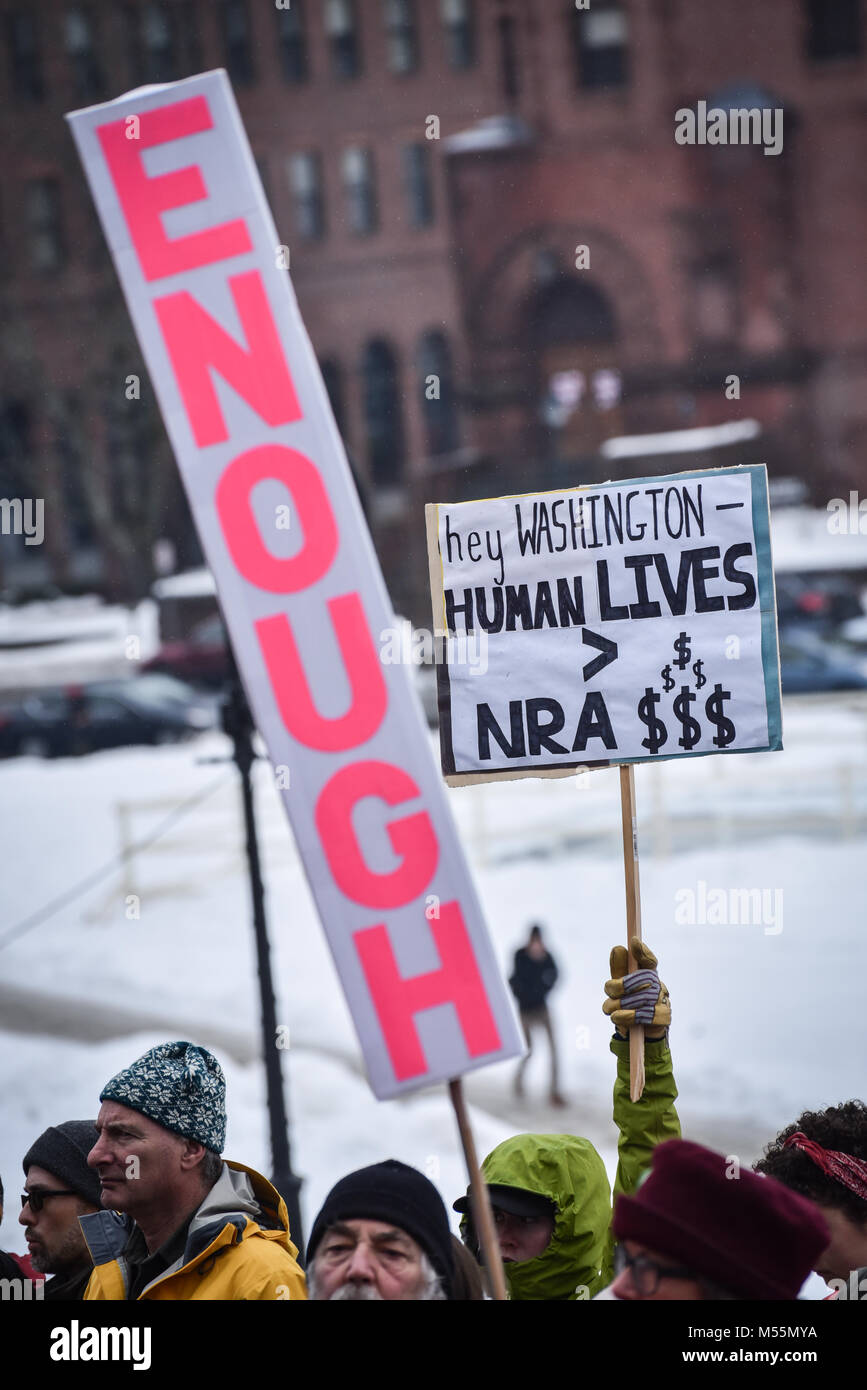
(611, 1037, 681, 1200)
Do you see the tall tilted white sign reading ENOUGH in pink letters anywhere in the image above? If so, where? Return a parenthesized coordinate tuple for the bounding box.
(68, 72, 524, 1097)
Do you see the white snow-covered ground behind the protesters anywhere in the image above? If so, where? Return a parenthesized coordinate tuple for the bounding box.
(0, 696, 867, 1289)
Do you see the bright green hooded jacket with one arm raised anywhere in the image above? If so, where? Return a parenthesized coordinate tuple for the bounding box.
(482, 1038, 681, 1301)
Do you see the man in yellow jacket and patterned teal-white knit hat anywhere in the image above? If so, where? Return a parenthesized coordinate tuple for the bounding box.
(79, 1043, 307, 1301)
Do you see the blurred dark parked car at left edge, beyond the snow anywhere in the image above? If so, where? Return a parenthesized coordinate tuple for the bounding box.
(0, 674, 215, 758)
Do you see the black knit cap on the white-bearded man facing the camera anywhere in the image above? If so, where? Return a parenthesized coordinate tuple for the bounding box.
(307, 1158, 454, 1298)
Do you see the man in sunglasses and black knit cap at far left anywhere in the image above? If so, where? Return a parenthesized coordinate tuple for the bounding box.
(18, 1120, 100, 1302)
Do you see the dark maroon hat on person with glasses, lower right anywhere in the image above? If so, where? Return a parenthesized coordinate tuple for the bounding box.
(613, 1138, 831, 1298)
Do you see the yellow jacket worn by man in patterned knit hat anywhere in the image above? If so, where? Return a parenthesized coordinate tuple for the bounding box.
(79, 1162, 307, 1300)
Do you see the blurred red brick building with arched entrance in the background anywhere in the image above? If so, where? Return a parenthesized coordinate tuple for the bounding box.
(0, 0, 867, 620)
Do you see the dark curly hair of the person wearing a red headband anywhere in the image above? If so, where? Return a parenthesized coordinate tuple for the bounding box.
(753, 1101, 867, 1222)
